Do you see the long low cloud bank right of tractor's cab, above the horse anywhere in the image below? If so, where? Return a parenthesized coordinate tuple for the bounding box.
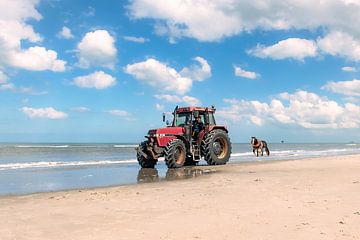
(218, 91, 360, 129)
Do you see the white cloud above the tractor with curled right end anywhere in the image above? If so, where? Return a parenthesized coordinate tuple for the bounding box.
(125, 57, 211, 95)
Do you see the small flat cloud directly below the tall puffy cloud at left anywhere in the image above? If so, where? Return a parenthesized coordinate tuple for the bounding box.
(74, 71, 116, 89)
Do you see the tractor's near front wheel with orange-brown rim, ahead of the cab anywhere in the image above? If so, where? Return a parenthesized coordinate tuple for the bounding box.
(164, 139, 186, 168)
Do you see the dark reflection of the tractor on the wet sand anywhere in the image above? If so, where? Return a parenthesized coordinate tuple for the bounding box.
(137, 167, 216, 183)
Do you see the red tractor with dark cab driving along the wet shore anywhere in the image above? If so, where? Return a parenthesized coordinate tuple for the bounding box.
(137, 107, 231, 168)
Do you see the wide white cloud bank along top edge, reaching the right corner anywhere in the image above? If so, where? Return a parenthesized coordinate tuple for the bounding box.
(128, 0, 360, 42)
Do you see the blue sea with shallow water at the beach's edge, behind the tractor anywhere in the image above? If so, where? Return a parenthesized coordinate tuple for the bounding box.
(0, 143, 360, 195)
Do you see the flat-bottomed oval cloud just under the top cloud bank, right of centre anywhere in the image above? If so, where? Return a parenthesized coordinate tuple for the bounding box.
(247, 38, 318, 61)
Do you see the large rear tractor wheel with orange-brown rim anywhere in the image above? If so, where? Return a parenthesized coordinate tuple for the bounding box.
(202, 130, 231, 165)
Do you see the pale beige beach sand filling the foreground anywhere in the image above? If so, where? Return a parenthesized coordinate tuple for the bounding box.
(0, 155, 360, 240)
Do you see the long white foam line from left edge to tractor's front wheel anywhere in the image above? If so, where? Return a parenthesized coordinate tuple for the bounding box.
(0, 159, 137, 170)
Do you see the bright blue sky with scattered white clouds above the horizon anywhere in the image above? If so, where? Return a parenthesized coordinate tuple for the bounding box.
(0, 0, 360, 143)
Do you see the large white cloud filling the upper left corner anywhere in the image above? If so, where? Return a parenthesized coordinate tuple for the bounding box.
(0, 0, 66, 72)
